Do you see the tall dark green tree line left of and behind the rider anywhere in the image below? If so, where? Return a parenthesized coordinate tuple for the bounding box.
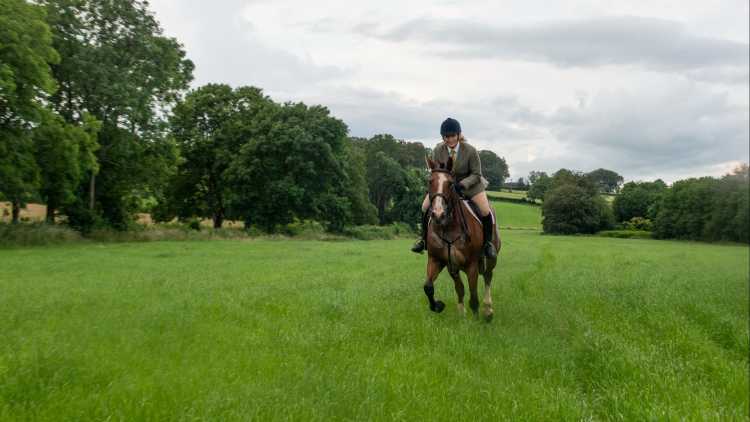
(0, 0, 508, 232)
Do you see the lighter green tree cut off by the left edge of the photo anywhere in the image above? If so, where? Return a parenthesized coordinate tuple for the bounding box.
(0, 0, 59, 222)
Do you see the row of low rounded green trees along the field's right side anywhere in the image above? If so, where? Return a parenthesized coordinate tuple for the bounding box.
(527, 164, 750, 243)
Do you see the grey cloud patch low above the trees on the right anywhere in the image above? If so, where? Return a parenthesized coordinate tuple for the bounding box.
(549, 83, 750, 178)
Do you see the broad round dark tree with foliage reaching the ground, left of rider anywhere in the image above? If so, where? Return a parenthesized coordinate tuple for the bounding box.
(227, 103, 352, 231)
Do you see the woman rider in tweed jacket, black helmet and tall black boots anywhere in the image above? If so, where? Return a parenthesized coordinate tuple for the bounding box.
(411, 117, 497, 258)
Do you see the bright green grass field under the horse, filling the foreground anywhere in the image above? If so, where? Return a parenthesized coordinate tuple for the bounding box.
(0, 231, 748, 421)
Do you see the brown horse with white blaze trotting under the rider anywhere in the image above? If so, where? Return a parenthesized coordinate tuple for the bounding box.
(424, 158, 500, 321)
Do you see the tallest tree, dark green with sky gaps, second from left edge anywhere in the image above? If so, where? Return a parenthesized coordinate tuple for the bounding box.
(40, 0, 193, 227)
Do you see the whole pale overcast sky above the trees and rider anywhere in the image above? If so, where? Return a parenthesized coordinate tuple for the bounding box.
(151, 0, 750, 182)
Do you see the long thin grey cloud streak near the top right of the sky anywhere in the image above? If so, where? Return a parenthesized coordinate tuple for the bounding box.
(360, 16, 750, 83)
